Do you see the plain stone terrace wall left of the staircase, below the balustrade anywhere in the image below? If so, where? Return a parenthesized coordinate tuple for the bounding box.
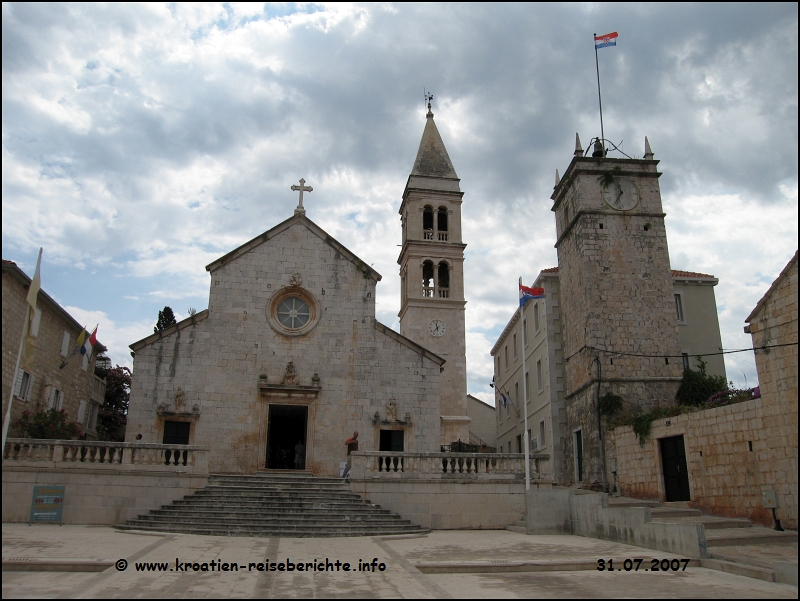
(3, 464, 208, 526)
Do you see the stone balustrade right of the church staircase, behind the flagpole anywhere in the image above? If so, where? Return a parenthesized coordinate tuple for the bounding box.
(350, 451, 552, 481)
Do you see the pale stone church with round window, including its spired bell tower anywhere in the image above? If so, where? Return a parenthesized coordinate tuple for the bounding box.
(126, 106, 470, 476)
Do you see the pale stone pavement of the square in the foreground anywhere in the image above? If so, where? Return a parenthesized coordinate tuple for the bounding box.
(2, 524, 798, 598)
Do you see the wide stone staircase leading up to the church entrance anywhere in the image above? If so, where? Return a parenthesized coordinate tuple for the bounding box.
(117, 473, 429, 537)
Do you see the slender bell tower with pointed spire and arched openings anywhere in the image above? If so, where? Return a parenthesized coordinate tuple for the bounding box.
(397, 103, 470, 444)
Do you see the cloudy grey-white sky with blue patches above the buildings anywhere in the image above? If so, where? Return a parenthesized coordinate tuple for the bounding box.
(2, 3, 798, 401)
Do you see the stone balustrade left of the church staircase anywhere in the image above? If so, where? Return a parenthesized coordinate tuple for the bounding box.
(3, 438, 208, 475)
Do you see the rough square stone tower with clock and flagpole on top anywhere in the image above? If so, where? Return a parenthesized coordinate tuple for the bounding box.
(551, 136, 683, 488)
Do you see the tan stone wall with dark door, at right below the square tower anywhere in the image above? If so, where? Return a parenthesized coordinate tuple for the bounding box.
(606, 398, 797, 528)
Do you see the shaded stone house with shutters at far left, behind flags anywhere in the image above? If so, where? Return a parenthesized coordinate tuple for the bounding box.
(3, 260, 105, 439)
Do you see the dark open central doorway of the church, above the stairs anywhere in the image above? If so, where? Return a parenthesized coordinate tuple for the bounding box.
(266, 405, 308, 470)
